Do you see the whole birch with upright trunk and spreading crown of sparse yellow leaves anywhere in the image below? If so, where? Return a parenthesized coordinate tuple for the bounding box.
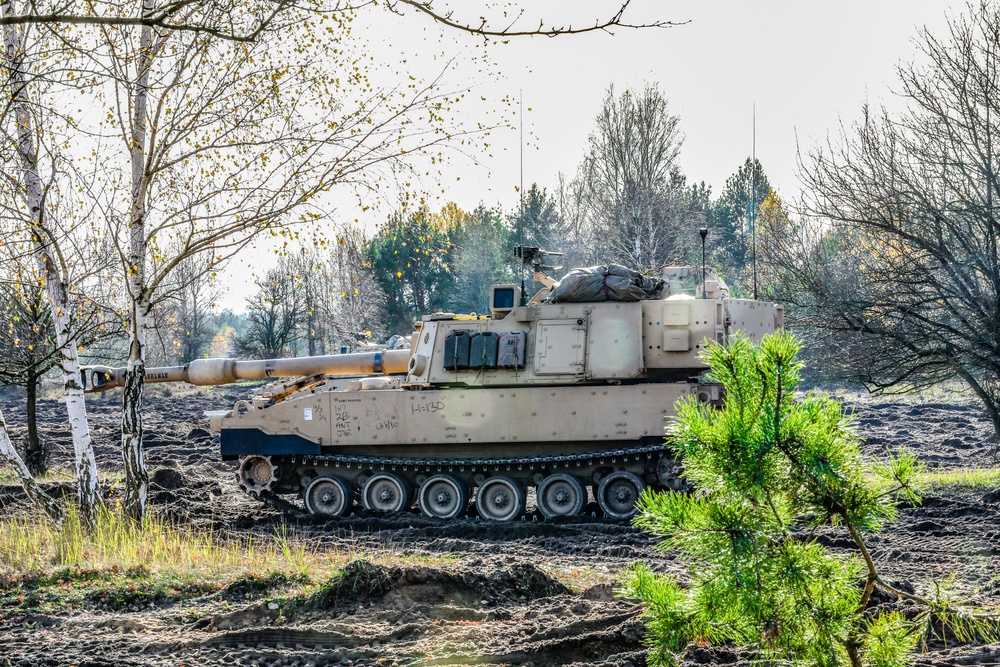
(73, 1, 500, 517)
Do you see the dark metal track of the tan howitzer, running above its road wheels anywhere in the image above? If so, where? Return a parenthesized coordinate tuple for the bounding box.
(244, 444, 671, 519)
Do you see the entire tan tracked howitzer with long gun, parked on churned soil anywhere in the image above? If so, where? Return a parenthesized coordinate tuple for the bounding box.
(87, 248, 782, 521)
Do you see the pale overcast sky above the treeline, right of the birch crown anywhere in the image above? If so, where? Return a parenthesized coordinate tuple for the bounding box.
(221, 0, 965, 310)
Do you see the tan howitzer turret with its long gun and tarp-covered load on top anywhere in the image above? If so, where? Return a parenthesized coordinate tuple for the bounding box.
(84, 253, 782, 392)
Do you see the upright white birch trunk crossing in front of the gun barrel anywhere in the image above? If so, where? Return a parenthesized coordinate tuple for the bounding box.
(122, 7, 153, 521)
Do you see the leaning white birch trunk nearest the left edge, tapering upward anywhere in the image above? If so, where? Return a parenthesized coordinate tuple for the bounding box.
(0, 2, 101, 525)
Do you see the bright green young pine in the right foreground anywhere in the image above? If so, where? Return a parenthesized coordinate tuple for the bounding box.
(624, 332, 997, 667)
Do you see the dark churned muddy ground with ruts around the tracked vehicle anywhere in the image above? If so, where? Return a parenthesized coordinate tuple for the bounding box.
(0, 389, 1000, 666)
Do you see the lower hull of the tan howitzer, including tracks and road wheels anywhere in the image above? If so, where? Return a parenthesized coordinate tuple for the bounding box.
(220, 383, 717, 520)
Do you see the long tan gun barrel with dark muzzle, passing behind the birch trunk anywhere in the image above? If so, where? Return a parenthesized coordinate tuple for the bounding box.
(82, 350, 410, 393)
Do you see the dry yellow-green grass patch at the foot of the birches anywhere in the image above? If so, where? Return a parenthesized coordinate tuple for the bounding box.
(0, 512, 466, 619)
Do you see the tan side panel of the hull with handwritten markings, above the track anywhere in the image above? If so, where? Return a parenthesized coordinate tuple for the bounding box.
(222, 383, 698, 457)
